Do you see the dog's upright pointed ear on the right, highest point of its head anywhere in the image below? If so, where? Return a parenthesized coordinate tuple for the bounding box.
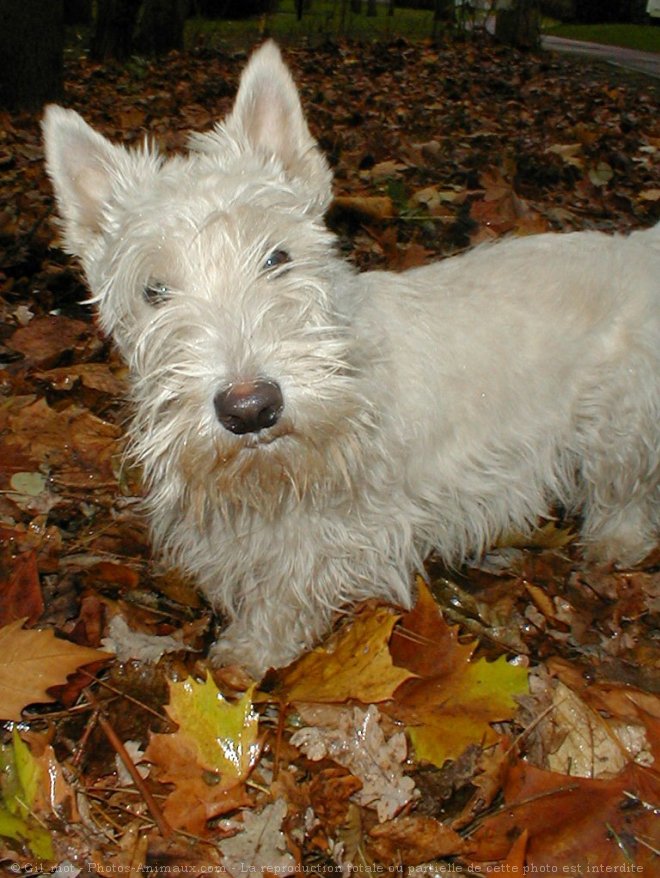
(225, 40, 332, 209)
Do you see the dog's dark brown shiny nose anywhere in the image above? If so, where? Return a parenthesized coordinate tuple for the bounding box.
(213, 380, 284, 435)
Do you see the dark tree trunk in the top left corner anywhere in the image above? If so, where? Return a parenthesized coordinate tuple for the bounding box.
(0, 0, 64, 109)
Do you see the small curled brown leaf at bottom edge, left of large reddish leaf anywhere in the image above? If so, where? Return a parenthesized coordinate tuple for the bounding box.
(368, 814, 465, 866)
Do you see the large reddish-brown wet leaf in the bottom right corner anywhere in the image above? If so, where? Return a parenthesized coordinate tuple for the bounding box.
(467, 761, 660, 874)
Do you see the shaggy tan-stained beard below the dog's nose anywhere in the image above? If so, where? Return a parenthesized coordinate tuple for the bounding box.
(130, 382, 375, 523)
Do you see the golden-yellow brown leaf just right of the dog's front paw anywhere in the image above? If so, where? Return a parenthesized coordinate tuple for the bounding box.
(278, 607, 415, 704)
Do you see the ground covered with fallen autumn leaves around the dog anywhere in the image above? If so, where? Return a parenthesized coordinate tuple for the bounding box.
(0, 42, 660, 876)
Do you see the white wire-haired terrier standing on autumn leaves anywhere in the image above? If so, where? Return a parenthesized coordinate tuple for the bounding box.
(44, 43, 660, 673)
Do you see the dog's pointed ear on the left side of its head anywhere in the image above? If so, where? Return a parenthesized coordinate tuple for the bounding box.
(42, 104, 126, 256)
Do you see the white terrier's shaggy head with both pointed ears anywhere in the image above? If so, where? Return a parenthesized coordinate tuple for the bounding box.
(43, 42, 376, 502)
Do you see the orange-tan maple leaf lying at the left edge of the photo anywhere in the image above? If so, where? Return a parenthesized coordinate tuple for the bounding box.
(0, 619, 112, 720)
